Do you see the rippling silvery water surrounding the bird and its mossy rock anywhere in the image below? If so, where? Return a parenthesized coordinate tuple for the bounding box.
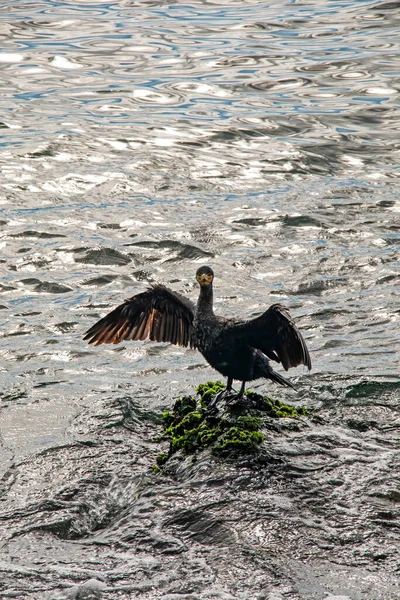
(0, 0, 400, 600)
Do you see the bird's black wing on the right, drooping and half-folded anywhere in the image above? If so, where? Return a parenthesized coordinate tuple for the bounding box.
(231, 304, 311, 371)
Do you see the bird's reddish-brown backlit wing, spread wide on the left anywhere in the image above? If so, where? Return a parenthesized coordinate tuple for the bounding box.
(83, 285, 195, 348)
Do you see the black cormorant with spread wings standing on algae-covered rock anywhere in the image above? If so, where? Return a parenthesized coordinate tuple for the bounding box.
(83, 267, 311, 399)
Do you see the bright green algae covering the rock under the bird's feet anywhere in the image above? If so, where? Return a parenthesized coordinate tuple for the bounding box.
(157, 381, 306, 467)
